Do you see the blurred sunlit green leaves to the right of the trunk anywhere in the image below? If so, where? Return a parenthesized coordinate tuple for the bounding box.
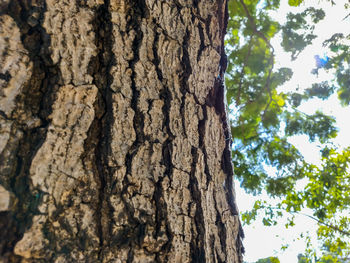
(225, 0, 350, 262)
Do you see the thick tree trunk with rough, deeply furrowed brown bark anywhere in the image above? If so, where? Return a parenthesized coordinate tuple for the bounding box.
(0, 0, 242, 263)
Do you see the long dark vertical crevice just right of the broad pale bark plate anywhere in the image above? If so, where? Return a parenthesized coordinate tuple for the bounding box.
(87, 0, 115, 262)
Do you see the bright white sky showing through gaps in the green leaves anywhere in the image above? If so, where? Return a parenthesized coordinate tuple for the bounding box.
(236, 0, 350, 263)
